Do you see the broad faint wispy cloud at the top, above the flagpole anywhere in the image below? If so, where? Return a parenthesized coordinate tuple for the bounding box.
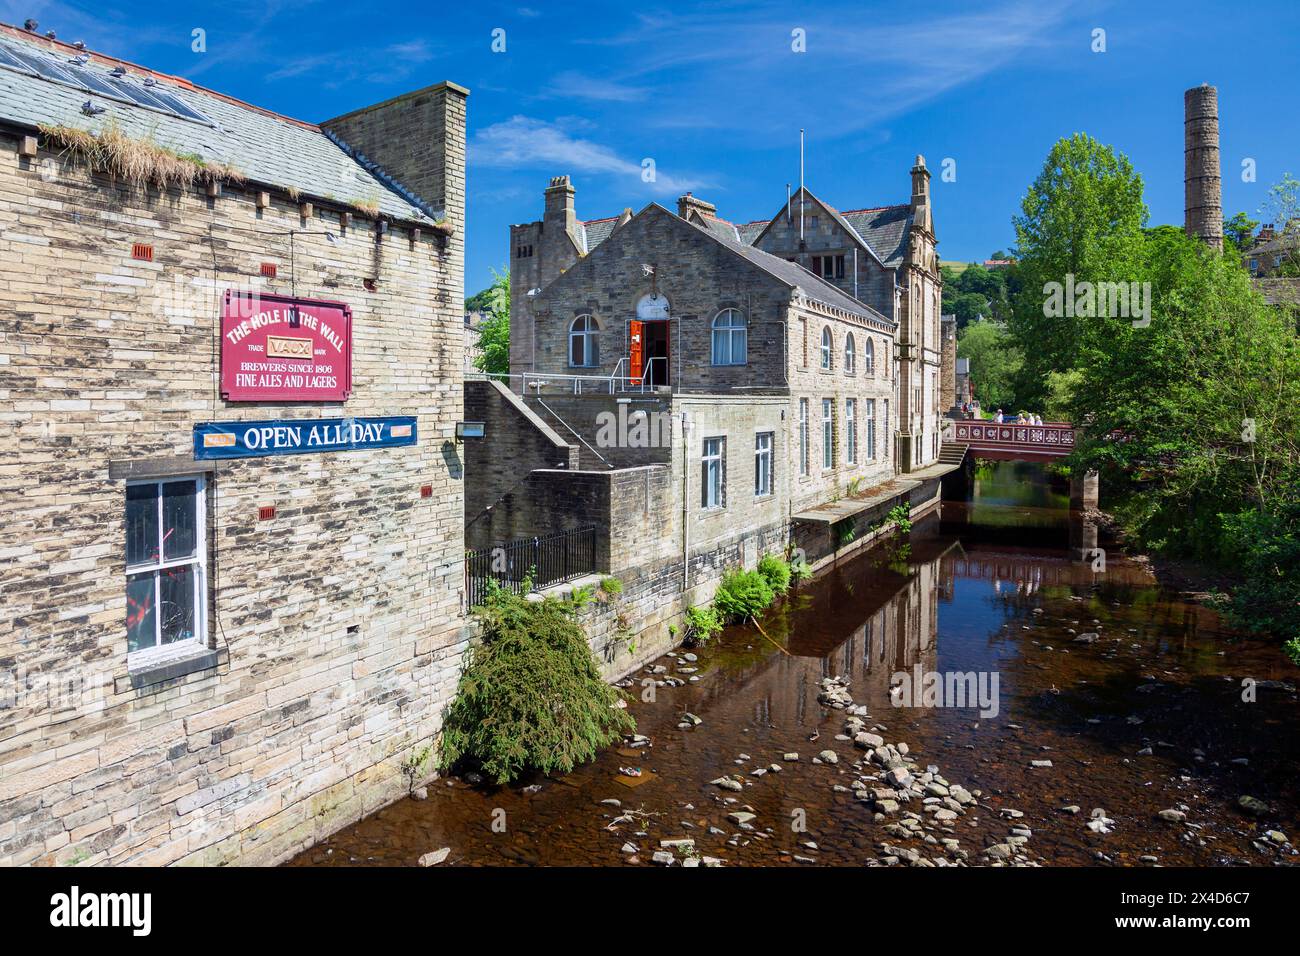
(564, 0, 1076, 140)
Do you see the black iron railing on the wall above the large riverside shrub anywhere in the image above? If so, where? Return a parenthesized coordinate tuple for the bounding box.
(465, 528, 595, 607)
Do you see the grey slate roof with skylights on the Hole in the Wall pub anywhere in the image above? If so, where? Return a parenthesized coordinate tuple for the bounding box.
(0, 23, 441, 221)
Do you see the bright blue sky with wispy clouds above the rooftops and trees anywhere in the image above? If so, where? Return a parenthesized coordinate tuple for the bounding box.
(10, 0, 1300, 293)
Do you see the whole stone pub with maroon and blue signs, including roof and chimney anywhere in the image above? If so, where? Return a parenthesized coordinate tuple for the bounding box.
(0, 26, 467, 865)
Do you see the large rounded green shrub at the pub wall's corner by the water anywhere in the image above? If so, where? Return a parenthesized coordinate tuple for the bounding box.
(439, 588, 636, 783)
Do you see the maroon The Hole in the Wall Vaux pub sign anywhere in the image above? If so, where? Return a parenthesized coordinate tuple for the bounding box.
(221, 290, 352, 402)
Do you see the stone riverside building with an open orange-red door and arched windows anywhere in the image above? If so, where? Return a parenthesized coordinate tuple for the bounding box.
(465, 159, 946, 674)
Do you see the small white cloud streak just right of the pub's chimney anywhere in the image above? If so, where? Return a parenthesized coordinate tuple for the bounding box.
(469, 116, 710, 194)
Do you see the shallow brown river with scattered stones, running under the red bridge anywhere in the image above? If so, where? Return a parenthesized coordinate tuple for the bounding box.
(290, 463, 1300, 866)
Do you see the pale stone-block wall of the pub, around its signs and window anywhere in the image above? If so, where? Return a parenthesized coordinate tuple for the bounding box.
(0, 101, 467, 865)
